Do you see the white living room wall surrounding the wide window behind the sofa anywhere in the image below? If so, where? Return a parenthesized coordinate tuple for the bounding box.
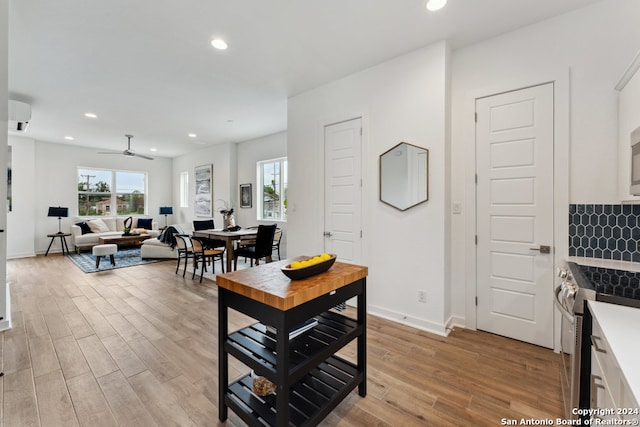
(8, 137, 172, 257)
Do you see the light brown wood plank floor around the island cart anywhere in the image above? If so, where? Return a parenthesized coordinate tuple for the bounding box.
(0, 254, 562, 427)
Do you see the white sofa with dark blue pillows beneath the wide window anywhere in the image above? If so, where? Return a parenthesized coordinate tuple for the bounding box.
(71, 216, 160, 252)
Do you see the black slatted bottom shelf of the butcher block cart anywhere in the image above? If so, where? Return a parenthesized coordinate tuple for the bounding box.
(225, 356, 363, 426)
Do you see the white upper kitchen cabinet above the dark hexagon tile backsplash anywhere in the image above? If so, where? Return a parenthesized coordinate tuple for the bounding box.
(616, 49, 640, 201)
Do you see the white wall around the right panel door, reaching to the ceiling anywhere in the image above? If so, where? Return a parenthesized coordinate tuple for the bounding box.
(451, 0, 640, 318)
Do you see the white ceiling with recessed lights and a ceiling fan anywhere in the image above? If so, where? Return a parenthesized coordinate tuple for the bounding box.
(9, 0, 597, 157)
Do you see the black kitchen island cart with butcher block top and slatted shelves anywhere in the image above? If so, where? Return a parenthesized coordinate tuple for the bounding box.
(216, 258, 368, 426)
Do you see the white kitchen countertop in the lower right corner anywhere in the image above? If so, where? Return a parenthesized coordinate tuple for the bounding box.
(589, 301, 640, 402)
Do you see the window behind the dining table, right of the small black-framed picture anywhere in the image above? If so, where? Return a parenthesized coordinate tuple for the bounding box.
(257, 157, 287, 221)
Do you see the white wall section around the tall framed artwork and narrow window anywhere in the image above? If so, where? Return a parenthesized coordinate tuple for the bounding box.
(169, 143, 238, 227)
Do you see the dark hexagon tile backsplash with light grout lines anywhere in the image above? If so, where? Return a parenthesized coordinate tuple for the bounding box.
(569, 205, 640, 262)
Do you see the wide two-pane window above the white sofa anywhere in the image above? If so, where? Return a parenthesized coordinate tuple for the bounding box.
(78, 168, 147, 216)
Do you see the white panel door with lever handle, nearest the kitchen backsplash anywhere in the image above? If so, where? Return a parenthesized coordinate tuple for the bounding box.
(476, 83, 554, 348)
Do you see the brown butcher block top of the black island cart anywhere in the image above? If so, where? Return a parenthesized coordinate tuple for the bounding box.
(216, 257, 369, 310)
